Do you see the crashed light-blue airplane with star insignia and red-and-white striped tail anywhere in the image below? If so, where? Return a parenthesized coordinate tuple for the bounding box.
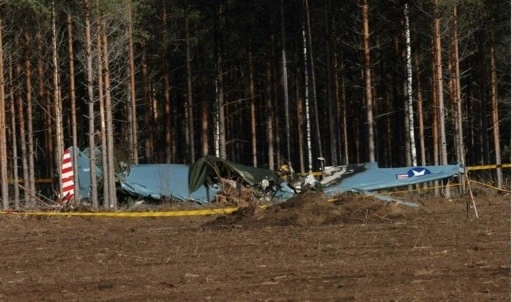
(61, 147, 464, 204)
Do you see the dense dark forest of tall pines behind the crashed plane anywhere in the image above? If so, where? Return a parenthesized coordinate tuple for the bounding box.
(0, 0, 511, 209)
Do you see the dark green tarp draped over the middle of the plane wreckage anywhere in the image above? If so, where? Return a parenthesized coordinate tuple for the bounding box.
(188, 155, 279, 192)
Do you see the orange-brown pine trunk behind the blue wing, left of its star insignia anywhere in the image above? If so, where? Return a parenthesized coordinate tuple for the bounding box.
(361, 0, 375, 162)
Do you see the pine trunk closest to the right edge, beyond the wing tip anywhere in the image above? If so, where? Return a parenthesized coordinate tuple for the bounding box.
(490, 32, 503, 189)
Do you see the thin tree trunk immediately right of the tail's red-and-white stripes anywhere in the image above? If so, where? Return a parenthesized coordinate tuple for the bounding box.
(66, 12, 82, 201)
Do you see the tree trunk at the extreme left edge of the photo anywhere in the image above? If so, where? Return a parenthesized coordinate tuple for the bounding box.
(0, 18, 9, 210)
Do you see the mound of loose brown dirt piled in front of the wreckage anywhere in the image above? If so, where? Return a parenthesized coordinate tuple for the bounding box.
(203, 192, 418, 228)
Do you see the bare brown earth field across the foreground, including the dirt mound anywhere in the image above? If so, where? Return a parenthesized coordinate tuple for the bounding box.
(0, 192, 511, 301)
